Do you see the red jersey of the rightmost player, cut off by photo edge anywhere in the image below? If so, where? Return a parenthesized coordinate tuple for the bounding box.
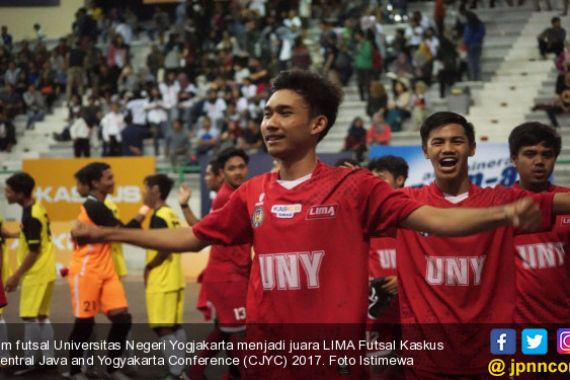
(514, 183, 570, 325)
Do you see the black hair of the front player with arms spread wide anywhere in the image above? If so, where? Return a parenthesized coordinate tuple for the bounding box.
(271, 69, 342, 141)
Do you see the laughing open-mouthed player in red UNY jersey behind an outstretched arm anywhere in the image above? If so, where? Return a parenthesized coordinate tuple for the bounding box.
(397, 112, 570, 379)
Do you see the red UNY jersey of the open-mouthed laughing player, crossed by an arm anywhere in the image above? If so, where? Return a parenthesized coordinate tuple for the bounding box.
(397, 183, 553, 374)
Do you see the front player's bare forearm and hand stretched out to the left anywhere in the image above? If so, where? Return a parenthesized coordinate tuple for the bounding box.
(71, 223, 210, 252)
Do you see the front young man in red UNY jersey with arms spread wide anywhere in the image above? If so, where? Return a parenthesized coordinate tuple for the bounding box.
(72, 70, 544, 375)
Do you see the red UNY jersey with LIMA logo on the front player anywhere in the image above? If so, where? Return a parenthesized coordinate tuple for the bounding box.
(193, 162, 421, 323)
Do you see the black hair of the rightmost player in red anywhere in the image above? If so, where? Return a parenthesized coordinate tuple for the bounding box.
(509, 121, 562, 158)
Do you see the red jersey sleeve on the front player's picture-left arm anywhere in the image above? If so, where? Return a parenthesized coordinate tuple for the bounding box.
(192, 184, 253, 245)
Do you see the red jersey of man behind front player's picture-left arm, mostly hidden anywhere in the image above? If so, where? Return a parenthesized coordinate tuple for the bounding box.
(203, 182, 251, 283)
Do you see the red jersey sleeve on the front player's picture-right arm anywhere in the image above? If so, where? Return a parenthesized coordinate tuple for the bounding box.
(361, 175, 423, 236)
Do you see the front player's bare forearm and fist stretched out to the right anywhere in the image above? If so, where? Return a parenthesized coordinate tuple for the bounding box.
(401, 198, 540, 236)
